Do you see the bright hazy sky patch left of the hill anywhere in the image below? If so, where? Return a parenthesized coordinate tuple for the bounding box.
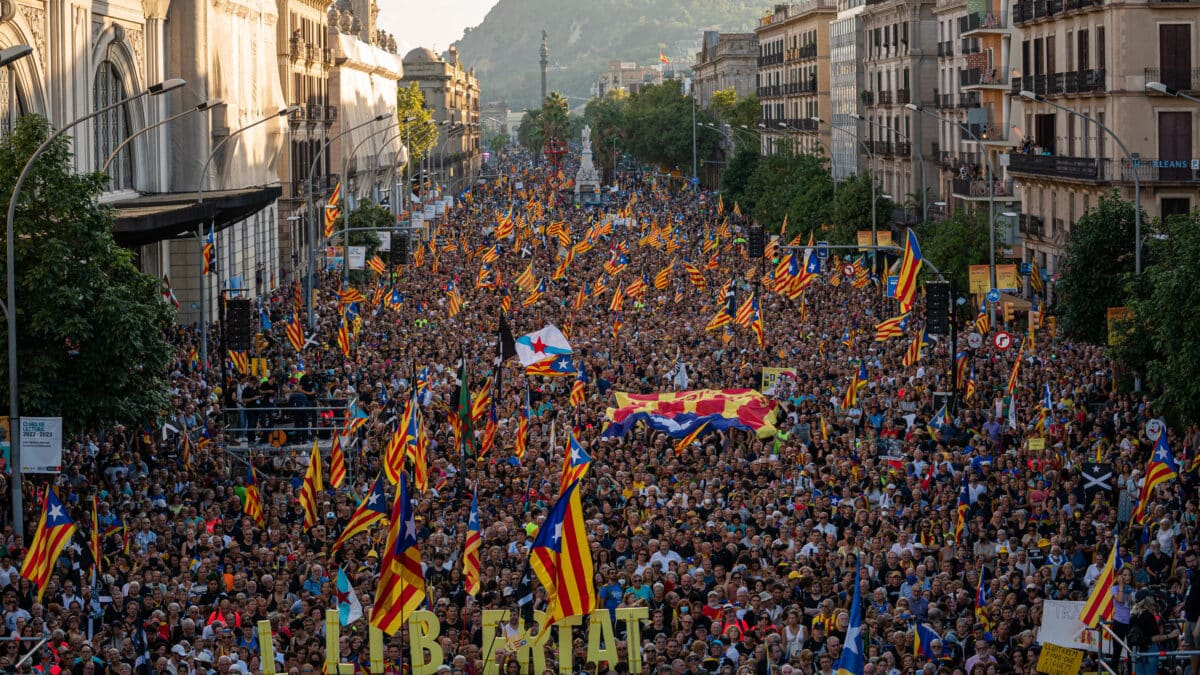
(377, 0, 497, 56)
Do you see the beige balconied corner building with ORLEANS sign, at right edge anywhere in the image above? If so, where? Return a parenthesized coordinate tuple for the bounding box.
(1008, 0, 1200, 273)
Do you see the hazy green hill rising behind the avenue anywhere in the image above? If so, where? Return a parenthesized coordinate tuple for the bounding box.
(455, 0, 772, 110)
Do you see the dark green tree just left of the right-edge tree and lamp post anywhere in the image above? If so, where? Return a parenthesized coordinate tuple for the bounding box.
(1055, 191, 1134, 345)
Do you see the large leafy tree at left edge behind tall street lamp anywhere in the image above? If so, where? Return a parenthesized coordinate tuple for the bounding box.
(0, 115, 174, 432)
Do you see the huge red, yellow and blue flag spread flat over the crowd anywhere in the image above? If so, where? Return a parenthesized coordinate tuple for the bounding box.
(602, 389, 778, 438)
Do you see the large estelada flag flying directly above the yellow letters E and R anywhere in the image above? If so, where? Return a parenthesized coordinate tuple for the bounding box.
(529, 482, 596, 626)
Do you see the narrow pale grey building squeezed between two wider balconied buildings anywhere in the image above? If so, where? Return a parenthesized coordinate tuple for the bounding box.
(829, 0, 866, 180)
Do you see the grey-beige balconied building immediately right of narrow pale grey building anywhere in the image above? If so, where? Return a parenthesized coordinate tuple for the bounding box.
(858, 0, 938, 210)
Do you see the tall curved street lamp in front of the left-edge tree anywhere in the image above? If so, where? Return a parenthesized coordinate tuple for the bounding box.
(0, 74, 187, 538)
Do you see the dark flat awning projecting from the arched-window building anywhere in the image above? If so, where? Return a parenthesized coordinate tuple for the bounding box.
(110, 185, 283, 247)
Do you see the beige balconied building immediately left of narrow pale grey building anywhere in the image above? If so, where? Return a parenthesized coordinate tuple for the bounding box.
(755, 0, 838, 156)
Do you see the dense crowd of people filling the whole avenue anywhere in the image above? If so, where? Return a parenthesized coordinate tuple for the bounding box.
(0, 148, 1200, 675)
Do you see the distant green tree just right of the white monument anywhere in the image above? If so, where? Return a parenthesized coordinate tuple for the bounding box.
(625, 79, 719, 173)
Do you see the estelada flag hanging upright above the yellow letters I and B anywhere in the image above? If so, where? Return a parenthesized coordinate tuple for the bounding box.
(371, 474, 427, 635)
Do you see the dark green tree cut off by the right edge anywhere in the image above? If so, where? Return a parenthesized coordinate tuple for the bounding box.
(1113, 207, 1200, 426)
